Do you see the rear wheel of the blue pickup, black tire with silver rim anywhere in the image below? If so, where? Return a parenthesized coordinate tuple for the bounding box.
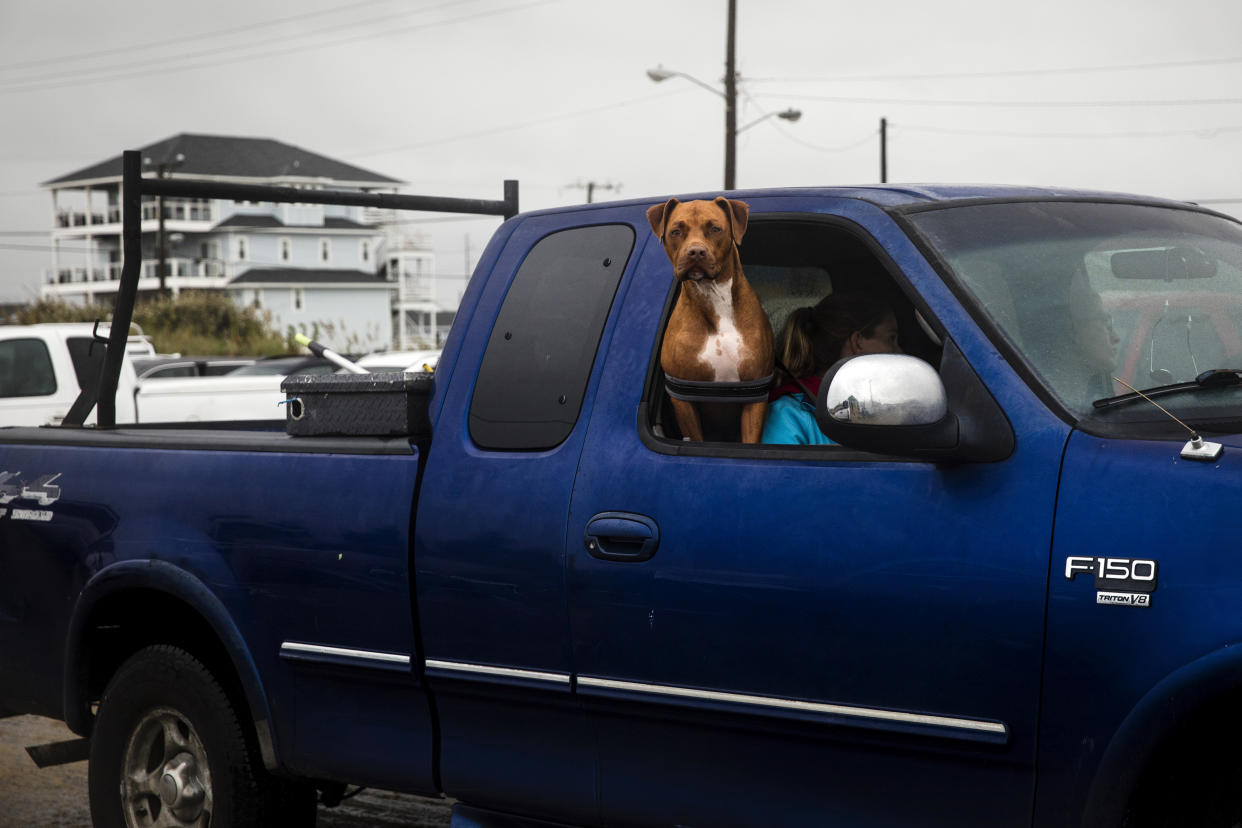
(88, 646, 315, 828)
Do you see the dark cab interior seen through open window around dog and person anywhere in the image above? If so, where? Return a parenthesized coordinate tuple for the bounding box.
(648, 214, 940, 448)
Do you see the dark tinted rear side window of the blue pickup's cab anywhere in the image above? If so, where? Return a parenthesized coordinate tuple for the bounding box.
(469, 225, 635, 451)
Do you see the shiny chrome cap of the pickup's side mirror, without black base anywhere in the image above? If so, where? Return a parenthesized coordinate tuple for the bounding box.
(820, 354, 949, 426)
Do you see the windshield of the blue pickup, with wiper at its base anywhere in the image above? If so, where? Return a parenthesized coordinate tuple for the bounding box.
(910, 202, 1242, 421)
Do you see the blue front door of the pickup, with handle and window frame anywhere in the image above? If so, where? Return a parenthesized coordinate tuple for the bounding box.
(568, 200, 1068, 826)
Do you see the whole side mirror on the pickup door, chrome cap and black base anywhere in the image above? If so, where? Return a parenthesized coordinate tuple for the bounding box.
(815, 354, 960, 457)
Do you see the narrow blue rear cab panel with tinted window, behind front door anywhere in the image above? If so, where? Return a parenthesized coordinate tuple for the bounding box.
(415, 212, 636, 824)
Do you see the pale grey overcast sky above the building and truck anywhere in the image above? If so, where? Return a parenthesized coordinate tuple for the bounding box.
(0, 0, 1242, 300)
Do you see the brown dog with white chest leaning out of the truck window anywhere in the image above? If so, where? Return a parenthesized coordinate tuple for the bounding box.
(647, 196, 773, 443)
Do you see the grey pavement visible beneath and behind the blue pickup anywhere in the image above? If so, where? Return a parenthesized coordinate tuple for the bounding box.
(0, 716, 448, 828)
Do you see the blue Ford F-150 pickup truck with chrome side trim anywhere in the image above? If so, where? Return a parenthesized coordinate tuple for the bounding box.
(0, 165, 1242, 828)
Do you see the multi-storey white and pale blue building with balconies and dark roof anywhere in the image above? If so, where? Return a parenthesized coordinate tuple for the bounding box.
(42, 134, 450, 351)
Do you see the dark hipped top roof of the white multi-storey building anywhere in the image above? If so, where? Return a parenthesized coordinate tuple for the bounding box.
(42, 133, 402, 186)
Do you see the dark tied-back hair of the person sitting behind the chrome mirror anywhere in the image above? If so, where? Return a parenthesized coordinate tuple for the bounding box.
(776, 292, 893, 380)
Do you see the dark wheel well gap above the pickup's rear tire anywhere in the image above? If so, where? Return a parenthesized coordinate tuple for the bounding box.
(78, 590, 248, 719)
